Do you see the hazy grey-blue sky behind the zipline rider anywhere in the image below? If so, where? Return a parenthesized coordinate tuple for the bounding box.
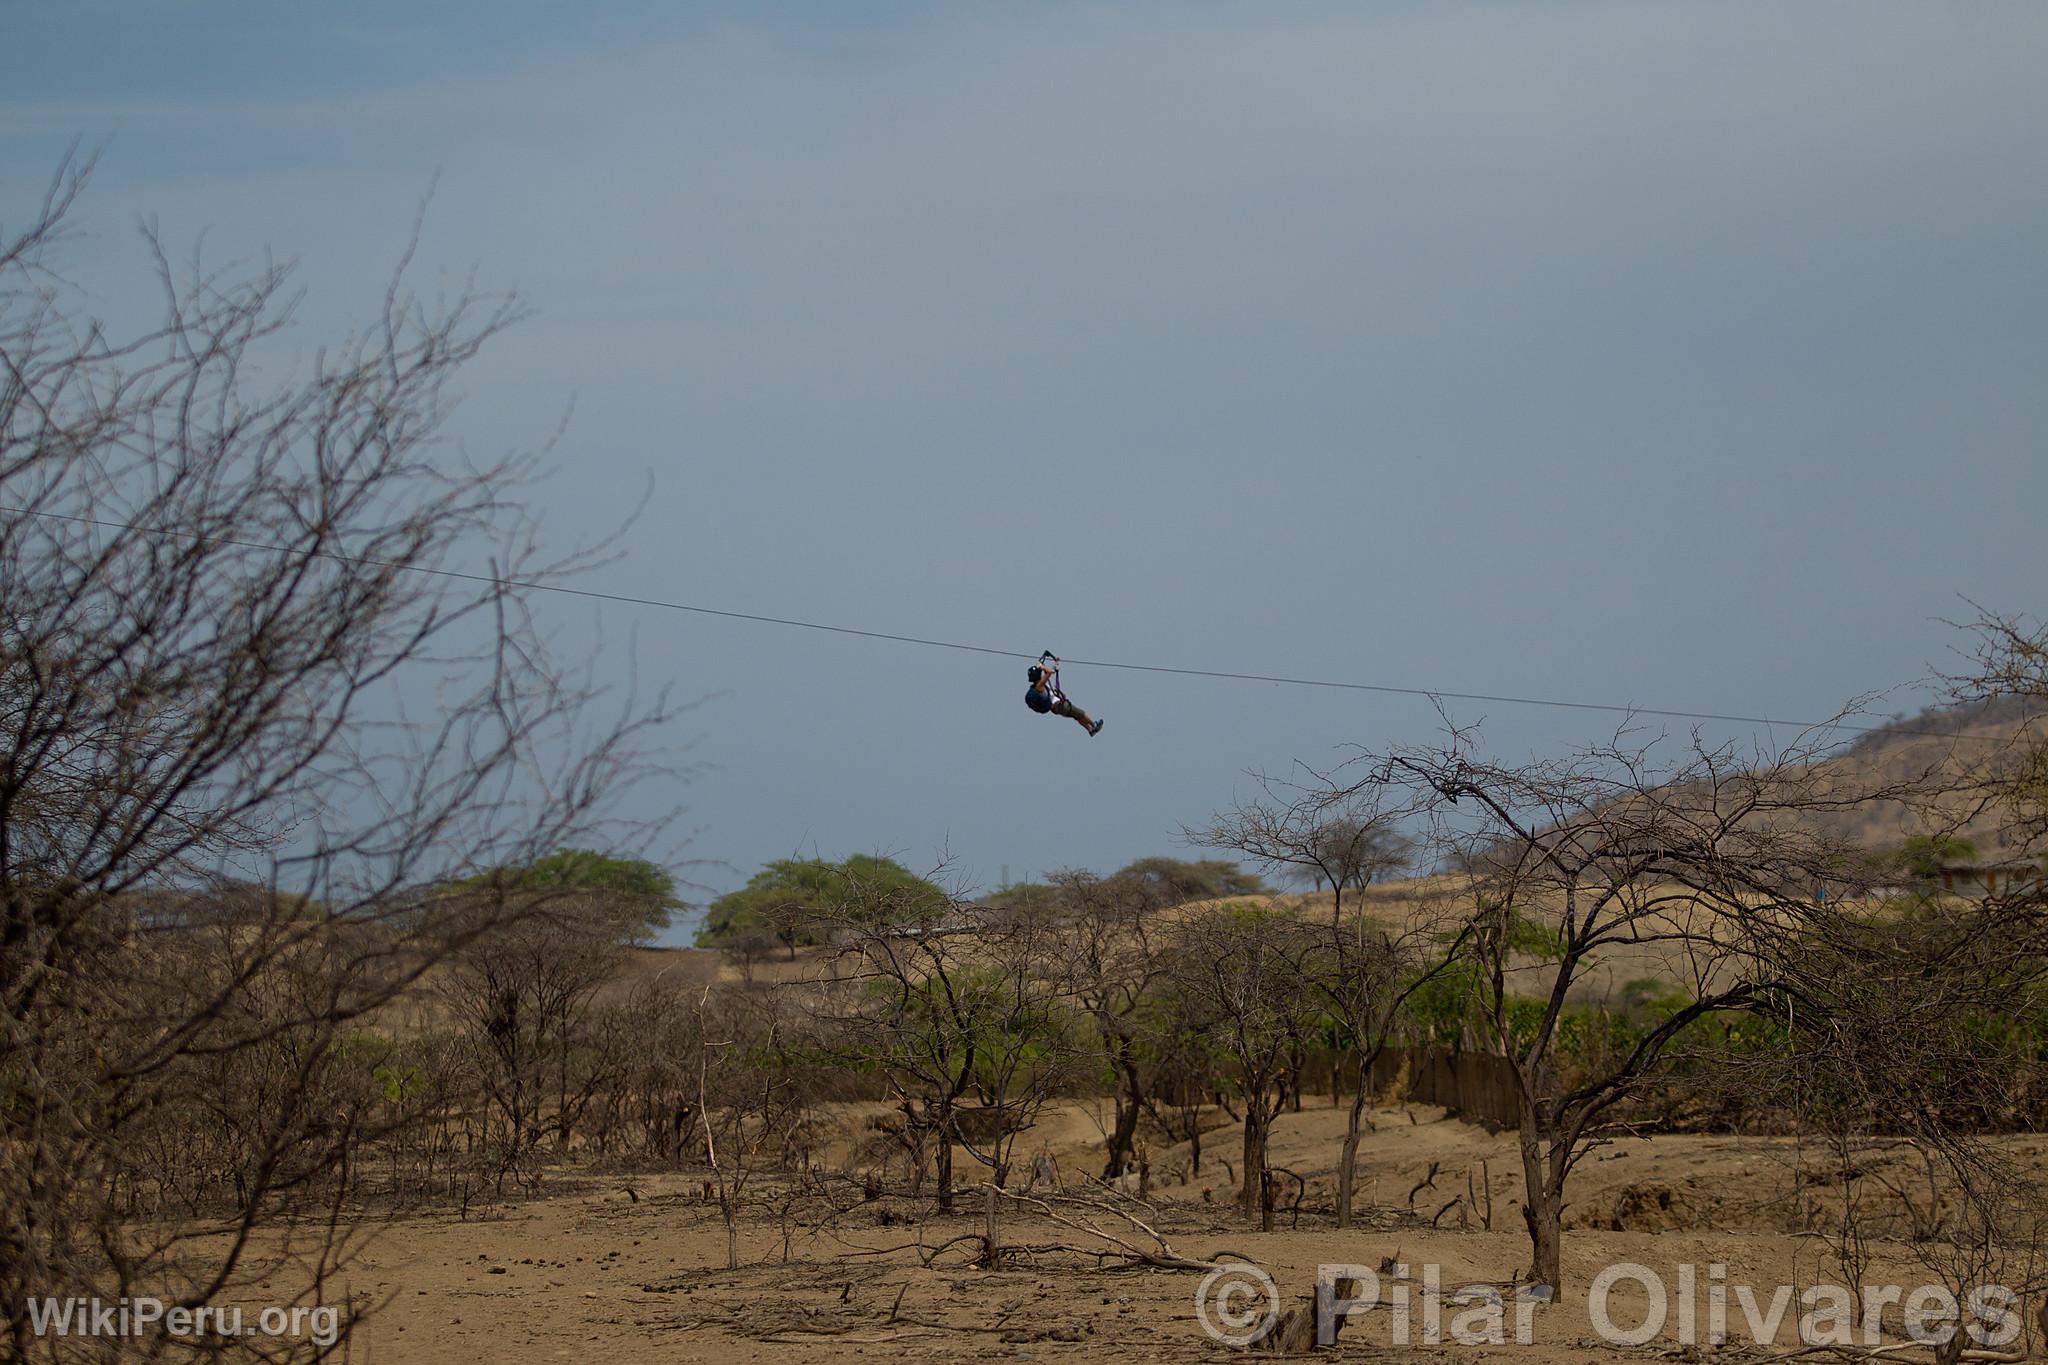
(0, 0, 2048, 933)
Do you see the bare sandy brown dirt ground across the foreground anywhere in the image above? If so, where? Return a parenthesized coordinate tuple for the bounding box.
(299, 1101, 2048, 1365)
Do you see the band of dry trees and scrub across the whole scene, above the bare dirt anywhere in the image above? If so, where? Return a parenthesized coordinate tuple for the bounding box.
(12, 157, 2048, 1359)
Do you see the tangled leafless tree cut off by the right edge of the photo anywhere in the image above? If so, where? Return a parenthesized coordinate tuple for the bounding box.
(1753, 612, 2048, 1361)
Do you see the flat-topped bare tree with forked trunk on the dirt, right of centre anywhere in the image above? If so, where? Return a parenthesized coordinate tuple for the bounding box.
(1350, 716, 1892, 1285)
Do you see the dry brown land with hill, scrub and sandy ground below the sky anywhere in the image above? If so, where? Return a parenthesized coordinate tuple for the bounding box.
(16, 699, 2048, 1365)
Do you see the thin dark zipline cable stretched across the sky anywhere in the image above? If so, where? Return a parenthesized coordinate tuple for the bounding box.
(0, 508, 1991, 739)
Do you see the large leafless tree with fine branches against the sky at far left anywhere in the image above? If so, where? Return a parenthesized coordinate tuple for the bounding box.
(0, 154, 659, 1359)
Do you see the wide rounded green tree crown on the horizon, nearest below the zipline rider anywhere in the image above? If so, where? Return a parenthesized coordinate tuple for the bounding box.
(696, 853, 948, 958)
